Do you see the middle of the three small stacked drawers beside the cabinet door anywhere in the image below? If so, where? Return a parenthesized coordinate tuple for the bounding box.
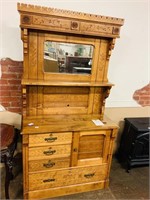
(29, 144, 71, 160)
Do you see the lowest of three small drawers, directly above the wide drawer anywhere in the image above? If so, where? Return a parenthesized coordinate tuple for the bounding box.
(29, 157, 70, 172)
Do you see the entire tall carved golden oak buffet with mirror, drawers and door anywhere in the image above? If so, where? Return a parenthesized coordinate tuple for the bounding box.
(18, 4, 124, 199)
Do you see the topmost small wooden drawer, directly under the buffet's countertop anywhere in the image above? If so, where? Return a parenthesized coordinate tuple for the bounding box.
(29, 132, 72, 147)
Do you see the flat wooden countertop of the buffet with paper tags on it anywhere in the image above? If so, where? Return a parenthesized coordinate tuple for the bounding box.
(22, 115, 118, 134)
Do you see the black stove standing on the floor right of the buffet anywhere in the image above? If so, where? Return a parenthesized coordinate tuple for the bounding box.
(117, 117, 150, 172)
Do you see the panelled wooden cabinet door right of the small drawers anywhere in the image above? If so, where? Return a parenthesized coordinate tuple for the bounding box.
(71, 130, 111, 166)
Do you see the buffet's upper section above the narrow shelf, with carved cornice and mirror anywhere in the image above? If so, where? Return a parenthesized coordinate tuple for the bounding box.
(18, 3, 124, 85)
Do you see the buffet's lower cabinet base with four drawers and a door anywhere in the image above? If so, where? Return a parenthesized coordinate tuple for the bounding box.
(23, 126, 117, 199)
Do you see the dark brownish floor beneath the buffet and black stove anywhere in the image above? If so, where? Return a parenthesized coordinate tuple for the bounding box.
(1, 158, 149, 200)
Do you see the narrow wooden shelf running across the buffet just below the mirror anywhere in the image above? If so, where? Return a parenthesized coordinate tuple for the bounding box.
(21, 79, 114, 87)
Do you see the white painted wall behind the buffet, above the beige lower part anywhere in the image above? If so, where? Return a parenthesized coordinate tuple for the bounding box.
(0, 0, 150, 107)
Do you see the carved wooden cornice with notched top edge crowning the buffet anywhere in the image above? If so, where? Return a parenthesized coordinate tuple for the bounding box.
(18, 3, 124, 38)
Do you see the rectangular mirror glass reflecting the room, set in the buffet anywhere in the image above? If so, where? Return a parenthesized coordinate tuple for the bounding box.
(44, 41, 94, 74)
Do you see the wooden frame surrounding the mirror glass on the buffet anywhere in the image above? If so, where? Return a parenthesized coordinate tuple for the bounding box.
(38, 33, 100, 82)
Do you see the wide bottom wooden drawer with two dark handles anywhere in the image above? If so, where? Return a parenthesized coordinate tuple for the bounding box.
(29, 164, 107, 191)
